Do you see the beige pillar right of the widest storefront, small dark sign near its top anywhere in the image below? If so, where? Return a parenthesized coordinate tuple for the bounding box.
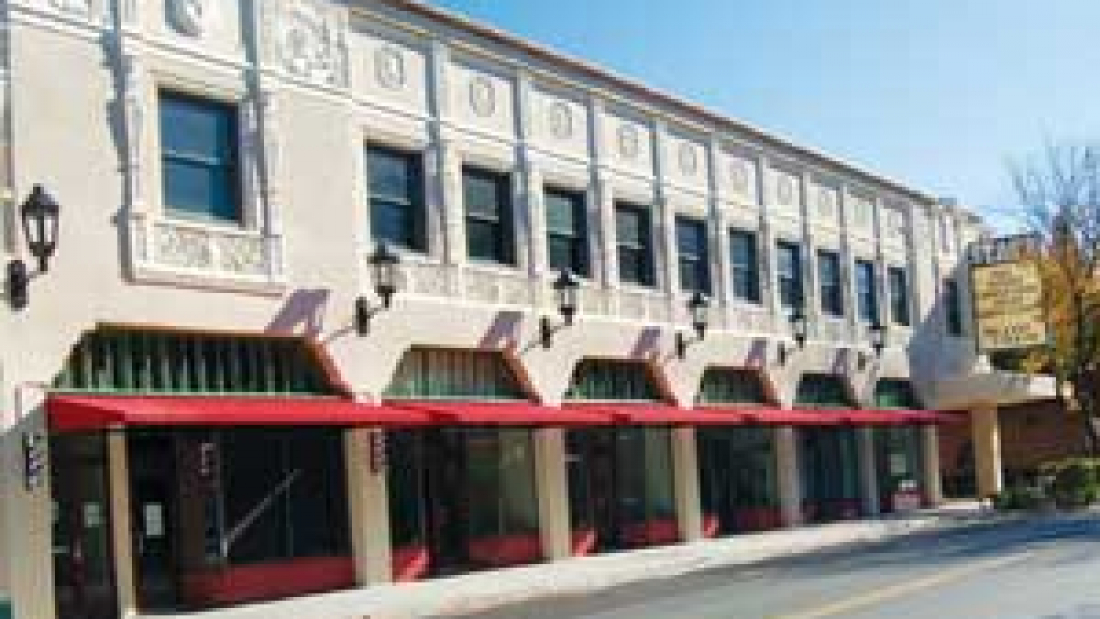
(344, 428, 393, 585)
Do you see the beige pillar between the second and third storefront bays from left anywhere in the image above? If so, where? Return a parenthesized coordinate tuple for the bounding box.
(531, 428, 573, 560)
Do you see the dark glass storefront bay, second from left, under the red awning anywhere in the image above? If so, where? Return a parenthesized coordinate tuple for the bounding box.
(387, 428, 542, 581)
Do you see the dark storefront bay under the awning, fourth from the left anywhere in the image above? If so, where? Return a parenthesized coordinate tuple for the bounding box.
(695, 428, 782, 537)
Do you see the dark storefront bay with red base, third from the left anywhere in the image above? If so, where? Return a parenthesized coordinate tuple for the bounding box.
(565, 428, 679, 555)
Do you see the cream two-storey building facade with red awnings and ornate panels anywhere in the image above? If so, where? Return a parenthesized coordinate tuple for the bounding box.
(0, 0, 989, 618)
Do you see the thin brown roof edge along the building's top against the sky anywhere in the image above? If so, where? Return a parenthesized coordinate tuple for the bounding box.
(380, 0, 972, 214)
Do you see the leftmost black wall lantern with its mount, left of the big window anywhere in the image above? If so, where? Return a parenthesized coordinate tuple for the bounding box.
(4, 185, 61, 311)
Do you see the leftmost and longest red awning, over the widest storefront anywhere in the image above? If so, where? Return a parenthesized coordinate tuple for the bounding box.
(46, 395, 431, 432)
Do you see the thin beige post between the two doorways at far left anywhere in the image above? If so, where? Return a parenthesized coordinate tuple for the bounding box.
(107, 432, 138, 617)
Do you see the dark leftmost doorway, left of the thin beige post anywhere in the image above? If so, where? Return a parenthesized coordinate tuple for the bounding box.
(50, 433, 119, 619)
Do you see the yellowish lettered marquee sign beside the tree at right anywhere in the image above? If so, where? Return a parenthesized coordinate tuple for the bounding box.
(970, 236, 1047, 352)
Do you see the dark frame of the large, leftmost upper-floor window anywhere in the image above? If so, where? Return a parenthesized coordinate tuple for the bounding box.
(156, 86, 248, 226)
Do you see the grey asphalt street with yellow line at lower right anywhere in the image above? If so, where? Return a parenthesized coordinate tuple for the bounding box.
(462, 515, 1100, 619)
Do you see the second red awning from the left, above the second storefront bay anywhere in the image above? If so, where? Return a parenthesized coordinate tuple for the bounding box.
(387, 400, 613, 425)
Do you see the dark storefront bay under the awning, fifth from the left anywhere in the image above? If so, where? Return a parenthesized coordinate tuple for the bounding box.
(799, 427, 864, 522)
